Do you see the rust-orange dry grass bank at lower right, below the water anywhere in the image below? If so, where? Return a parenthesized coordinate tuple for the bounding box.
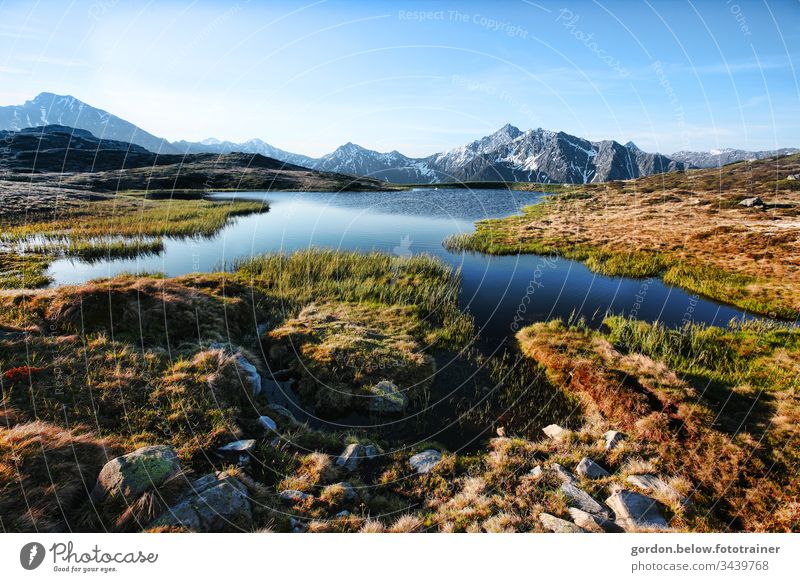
(518, 320, 800, 531)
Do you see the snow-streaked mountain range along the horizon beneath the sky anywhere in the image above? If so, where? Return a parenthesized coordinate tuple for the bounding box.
(0, 93, 800, 184)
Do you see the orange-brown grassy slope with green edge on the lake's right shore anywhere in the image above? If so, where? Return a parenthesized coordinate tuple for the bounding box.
(443, 156, 800, 320)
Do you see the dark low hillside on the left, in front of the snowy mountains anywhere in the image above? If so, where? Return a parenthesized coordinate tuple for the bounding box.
(0, 125, 385, 192)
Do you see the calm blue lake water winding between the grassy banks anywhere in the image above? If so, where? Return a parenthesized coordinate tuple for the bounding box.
(50, 189, 760, 350)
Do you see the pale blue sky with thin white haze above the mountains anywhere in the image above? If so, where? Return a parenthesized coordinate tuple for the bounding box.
(0, 0, 800, 155)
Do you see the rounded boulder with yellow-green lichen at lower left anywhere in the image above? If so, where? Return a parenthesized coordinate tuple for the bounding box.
(92, 445, 181, 502)
